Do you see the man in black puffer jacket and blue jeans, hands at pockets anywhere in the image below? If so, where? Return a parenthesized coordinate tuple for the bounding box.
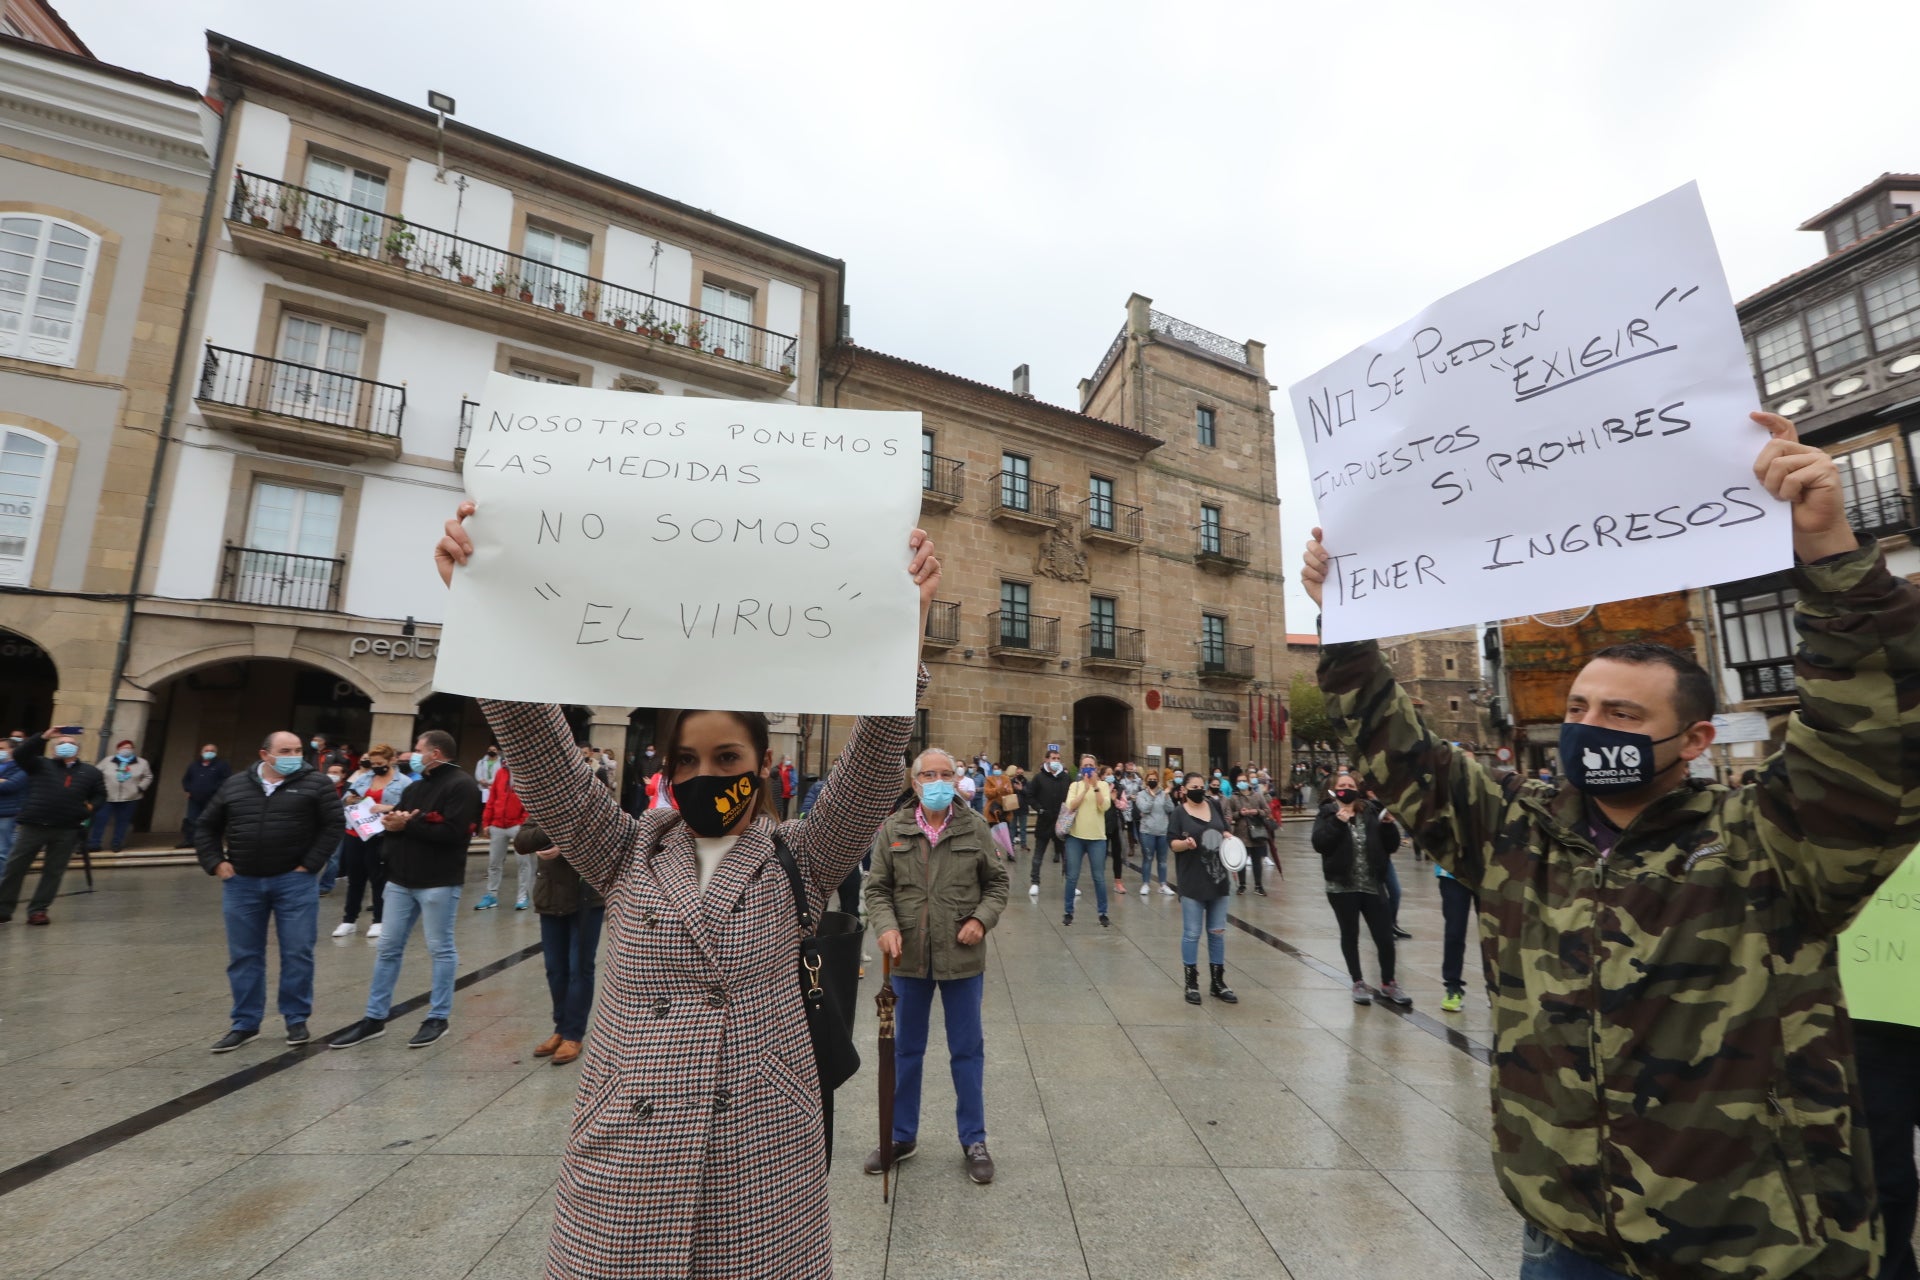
(194, 733, 346, 1054)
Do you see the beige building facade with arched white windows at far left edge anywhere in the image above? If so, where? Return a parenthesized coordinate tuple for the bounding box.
(0, 27, 215, 754)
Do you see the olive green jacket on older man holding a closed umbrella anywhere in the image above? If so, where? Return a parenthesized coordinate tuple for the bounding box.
(866, 800, 1006, 979)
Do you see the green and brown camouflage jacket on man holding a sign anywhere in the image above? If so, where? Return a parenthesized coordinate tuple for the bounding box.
(1319, 547, 1920, 1280)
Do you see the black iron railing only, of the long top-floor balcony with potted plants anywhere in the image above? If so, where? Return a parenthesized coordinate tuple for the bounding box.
(227, 171, 799, 376)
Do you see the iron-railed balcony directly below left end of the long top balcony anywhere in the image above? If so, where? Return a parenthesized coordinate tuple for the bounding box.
(194, 344, 407, 459)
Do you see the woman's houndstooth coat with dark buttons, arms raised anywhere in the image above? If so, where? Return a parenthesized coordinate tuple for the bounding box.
(482, 690, 925, 1280)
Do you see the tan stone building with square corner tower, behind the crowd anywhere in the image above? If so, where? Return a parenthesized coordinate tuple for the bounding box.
(812, 296, 1286, 782)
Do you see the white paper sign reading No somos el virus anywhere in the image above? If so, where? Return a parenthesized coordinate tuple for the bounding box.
(434, 374, 920, 716)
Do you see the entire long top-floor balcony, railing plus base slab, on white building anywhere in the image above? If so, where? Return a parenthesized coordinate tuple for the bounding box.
(227, 171, 799, 391)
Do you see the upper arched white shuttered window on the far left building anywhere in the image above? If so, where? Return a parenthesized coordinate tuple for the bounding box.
(0, 213, 100, 367)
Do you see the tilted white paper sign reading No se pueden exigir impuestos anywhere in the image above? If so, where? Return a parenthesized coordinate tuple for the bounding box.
(1290, 184, 1793, 641)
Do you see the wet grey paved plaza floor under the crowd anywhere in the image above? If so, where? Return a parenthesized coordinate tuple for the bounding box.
(0, 823, 1889, 1280)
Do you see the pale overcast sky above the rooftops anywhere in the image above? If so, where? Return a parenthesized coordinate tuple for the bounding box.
(58, 0, 1920, 631)
